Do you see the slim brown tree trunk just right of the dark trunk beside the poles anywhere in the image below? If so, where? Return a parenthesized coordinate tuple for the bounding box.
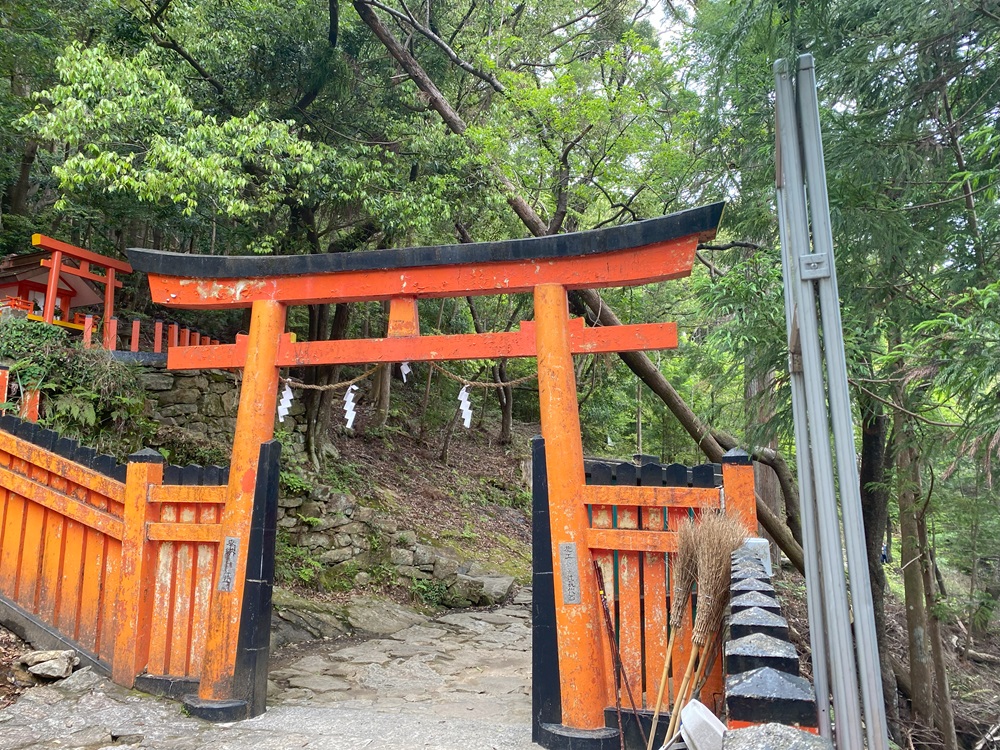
(894, 434, 934, 726)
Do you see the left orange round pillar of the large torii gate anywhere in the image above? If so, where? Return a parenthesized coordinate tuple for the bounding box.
(198, 301, 286, 700)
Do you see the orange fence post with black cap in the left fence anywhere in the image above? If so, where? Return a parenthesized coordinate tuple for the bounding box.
(111, 448, 163, 687)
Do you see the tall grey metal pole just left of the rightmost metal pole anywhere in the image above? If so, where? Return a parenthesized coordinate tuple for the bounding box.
(774, 60, 863, 750)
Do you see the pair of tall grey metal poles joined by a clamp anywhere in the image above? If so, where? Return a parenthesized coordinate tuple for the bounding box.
(774, 55, 889, 750)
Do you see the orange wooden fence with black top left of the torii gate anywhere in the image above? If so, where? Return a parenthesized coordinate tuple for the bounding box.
(0, 416, 276, 709)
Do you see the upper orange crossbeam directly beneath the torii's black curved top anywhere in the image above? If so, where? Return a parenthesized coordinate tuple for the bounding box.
(149, 235, 699, 310)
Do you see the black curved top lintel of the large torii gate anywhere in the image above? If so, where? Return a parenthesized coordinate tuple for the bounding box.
(128, 202, 725, 279)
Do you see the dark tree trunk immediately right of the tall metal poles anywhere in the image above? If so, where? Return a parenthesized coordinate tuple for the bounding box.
(858, 396, 900, 739)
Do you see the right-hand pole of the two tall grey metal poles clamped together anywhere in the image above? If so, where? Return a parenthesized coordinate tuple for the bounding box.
(796, 55, 889, 750)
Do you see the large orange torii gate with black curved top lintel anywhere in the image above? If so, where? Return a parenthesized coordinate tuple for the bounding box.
(129, 203, 753, 730)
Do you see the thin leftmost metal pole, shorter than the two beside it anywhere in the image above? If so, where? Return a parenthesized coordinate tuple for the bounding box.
(777, 188, 833, 739)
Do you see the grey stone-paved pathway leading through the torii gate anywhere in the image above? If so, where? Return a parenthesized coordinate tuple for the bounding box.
(0, 592, 537, 750)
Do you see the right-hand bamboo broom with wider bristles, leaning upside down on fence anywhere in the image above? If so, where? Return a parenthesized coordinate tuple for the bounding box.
(667, 513, 746, 738)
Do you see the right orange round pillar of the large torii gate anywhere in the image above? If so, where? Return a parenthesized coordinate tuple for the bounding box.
(532, 284, 610, 729)
